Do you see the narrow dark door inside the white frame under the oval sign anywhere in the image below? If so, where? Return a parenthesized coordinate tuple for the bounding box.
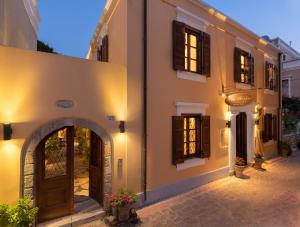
(236, 112, 248, 164)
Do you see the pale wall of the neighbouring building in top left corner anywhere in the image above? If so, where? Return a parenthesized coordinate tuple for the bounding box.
(0, 0, 39, 50)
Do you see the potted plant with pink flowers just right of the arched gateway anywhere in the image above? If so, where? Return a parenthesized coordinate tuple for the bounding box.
(111, 190, 137, 222)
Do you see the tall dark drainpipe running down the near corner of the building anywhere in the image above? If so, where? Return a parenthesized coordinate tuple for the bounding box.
(143, 0, 148, 201)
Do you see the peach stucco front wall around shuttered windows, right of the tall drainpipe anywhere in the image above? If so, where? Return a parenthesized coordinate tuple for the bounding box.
(148, 0, 278, 190)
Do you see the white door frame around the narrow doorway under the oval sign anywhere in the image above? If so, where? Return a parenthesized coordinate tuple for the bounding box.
(229, 103, 256, 173)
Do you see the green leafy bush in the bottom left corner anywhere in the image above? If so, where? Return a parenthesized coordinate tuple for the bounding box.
(0, 198, 38, 227)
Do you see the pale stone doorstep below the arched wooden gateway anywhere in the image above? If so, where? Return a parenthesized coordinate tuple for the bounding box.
(37, 208, 105, 227)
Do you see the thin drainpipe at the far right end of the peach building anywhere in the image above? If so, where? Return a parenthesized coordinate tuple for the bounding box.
(277, 53, 283, 152)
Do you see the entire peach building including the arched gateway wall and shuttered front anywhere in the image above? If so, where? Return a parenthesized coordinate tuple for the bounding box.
(0, 0, 281, 222)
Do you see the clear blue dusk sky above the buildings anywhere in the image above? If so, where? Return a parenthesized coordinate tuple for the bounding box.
(39, 0, 300, 58)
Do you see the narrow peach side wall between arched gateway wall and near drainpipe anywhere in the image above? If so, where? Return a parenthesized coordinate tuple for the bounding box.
(89, 0, 143, 195)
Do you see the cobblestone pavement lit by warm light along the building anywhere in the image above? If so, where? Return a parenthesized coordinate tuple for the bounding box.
(84, 152, 300, 227)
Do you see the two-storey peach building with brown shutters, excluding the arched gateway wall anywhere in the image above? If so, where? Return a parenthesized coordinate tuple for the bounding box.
(87, 0, 280, 202)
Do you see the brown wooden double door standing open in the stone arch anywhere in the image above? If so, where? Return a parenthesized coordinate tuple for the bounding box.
(35, 127, 103, 223)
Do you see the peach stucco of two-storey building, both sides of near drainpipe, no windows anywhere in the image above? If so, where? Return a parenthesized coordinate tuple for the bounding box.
(92, 0, 278, 195)
